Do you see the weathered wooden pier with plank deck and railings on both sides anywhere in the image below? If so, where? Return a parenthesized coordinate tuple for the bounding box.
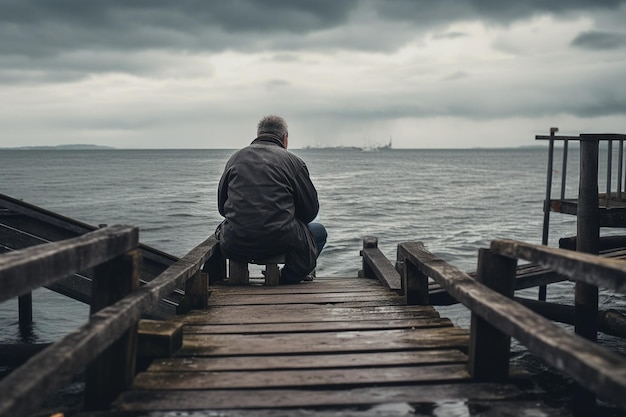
(0, 226, 626, 417)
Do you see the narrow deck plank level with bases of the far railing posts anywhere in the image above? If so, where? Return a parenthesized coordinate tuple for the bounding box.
(209, 292, 402, 306)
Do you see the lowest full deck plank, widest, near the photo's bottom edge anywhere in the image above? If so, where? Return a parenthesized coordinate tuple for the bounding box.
(115, 383, 528, 417)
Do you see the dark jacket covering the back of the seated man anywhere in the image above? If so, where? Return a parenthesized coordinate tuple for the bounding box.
(218, 135, 319, 260)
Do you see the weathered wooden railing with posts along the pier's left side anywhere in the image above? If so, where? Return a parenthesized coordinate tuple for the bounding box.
(0, 226, 223, 417)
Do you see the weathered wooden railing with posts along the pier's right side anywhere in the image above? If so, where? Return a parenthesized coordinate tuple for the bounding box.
(362, 240, 626, 415)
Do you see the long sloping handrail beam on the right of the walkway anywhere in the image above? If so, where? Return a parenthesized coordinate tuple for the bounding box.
(398, 242, 626, 408)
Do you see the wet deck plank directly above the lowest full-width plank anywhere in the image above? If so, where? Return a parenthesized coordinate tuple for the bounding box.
(133, 364, 470, 390)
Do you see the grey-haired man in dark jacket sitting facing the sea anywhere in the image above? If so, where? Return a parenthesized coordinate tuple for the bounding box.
(216, 116, 326, 284)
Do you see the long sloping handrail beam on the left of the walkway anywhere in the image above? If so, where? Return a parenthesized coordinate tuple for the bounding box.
(0, 229, 219, 417)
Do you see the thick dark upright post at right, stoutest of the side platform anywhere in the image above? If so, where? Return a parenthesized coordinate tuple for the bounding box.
(573, 135, 596, 415)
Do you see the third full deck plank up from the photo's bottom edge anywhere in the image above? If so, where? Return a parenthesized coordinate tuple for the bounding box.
(148, 349, 467, 372)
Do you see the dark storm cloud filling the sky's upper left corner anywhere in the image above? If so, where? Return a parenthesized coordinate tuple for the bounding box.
(0, 0, 356, 56)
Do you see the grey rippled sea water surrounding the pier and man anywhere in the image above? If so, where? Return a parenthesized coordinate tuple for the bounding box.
(0, 147, 626, 410)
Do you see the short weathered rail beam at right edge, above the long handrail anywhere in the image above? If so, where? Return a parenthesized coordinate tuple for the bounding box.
(491, 240, 626, 293)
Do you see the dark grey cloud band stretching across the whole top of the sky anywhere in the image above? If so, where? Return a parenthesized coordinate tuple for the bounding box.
(0, 0, 626, 56)
